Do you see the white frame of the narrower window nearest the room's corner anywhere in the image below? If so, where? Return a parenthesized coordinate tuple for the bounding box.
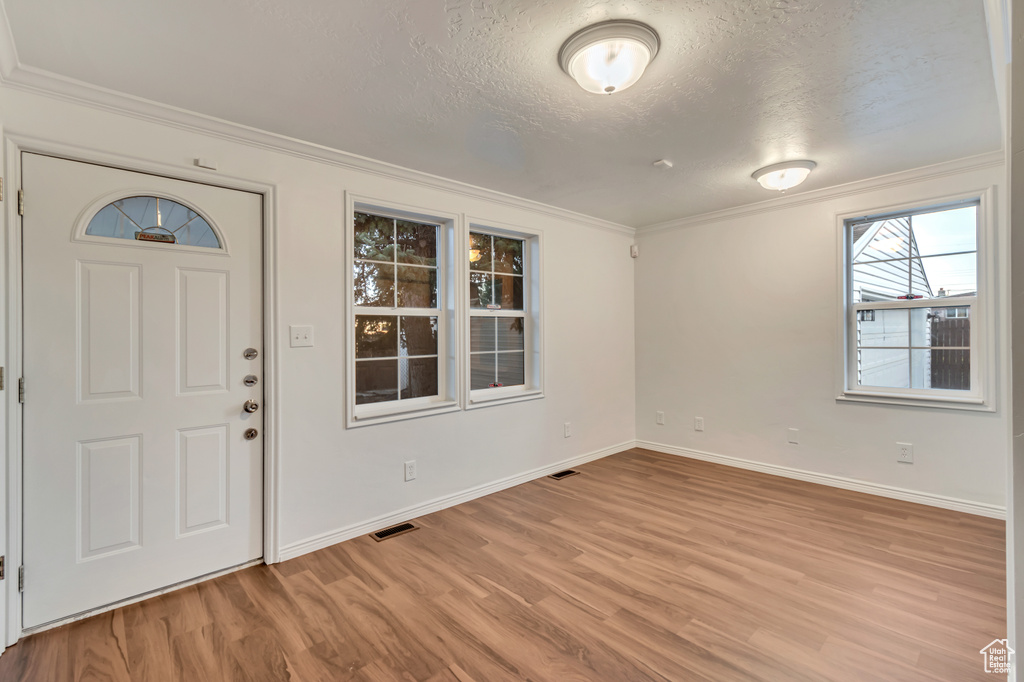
(459, 217, 544, 410)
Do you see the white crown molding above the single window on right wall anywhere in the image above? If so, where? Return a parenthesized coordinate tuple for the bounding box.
(636, 151, 1006, 235)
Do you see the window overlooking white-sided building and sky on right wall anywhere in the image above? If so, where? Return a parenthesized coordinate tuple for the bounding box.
(844, 199, 984, 402)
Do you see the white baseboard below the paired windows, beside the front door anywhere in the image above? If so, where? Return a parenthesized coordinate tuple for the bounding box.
(280, 440, 635, 561)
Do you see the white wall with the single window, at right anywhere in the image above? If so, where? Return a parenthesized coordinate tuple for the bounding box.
(636, 163, 1009, 506)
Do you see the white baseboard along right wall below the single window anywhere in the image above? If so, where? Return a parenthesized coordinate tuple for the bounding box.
(636, 440, 1007, 519)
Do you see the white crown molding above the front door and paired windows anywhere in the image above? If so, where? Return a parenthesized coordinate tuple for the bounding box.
(0, 31, 636, 237)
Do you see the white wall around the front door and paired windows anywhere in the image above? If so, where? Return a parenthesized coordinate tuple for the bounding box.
(0, 82, 635, 554)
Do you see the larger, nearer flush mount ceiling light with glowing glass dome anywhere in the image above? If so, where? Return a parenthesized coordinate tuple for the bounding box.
(558, 19, 658, 94)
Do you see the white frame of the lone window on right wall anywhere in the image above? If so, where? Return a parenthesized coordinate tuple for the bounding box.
(836, 187, 996, 412)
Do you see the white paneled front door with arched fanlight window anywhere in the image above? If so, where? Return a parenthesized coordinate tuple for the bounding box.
(22, 154, 263, 628)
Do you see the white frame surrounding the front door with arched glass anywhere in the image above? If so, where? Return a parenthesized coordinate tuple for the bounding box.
(0, 134, 281, 652)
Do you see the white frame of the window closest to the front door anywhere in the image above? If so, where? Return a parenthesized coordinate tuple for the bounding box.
(343, 193, 462, 428)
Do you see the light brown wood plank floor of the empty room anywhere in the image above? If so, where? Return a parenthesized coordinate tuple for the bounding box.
(0, 450, 1006, 682)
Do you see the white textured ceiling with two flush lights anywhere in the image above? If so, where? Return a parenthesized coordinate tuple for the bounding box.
(3, 0, 1000, 226)
